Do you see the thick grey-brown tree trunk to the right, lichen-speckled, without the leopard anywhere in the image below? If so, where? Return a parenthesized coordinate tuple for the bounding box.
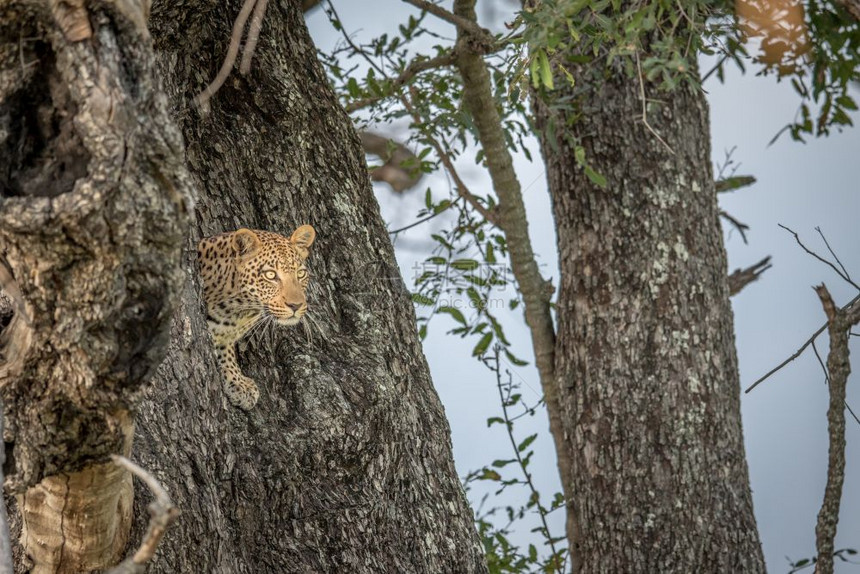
(536, 59, 764, 573)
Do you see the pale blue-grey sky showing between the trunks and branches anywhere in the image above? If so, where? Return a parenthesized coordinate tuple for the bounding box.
(308, 0, 860, 574)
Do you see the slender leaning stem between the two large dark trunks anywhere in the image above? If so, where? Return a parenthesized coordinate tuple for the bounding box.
(454, 0, 575, 565)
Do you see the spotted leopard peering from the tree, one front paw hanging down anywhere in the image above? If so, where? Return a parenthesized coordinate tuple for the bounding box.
(197, 225, 316, 411)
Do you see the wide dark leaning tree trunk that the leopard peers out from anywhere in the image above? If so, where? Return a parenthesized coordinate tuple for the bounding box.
(0, 0, 486, 573)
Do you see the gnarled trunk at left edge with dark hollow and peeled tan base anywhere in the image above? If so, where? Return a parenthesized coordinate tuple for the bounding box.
(0, 1, 190, 572)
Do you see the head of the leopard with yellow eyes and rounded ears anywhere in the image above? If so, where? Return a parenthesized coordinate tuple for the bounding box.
(231, 225, 316, 325)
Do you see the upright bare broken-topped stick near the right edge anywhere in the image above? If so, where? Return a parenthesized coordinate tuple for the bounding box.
(815, 283, 860, 574)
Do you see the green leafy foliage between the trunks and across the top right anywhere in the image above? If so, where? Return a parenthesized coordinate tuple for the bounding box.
(320, 0, 860, 572)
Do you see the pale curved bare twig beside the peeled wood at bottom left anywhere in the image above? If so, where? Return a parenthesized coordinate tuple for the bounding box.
(107, 455, 179, 574)
